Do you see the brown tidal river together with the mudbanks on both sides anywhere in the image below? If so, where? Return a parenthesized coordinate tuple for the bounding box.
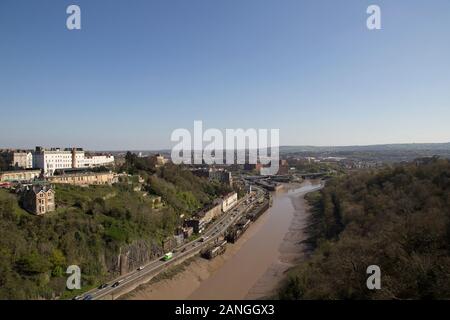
(124, 181, 316, 300)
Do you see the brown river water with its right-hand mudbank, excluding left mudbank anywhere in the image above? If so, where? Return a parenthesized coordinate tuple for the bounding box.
(188, 181, 319, 299)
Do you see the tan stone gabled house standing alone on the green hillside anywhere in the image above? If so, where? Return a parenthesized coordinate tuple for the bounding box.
(21, 184, 55, 215)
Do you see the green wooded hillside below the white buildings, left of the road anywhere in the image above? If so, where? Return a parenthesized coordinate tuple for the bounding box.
(0, 160, 227, 299)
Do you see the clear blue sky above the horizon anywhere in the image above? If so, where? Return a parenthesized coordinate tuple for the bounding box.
(0, 0, 450, 150)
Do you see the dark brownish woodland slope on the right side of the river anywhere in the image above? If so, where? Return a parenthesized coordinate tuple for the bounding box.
(280, 159, 450, 299)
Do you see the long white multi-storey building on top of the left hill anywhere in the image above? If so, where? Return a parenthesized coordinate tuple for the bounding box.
(33, 147, 114, 176)
